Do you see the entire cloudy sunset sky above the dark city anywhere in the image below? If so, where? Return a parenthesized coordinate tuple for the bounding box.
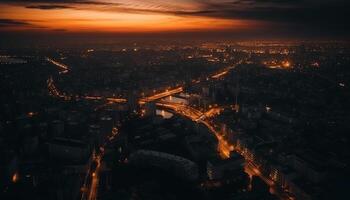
(0, 0, 350, 36)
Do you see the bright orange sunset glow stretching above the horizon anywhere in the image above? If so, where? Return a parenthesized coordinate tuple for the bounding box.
(0, 5, 257, 33)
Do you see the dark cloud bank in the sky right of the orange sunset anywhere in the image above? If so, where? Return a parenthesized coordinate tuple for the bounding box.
(185, 0, 350, 32)
